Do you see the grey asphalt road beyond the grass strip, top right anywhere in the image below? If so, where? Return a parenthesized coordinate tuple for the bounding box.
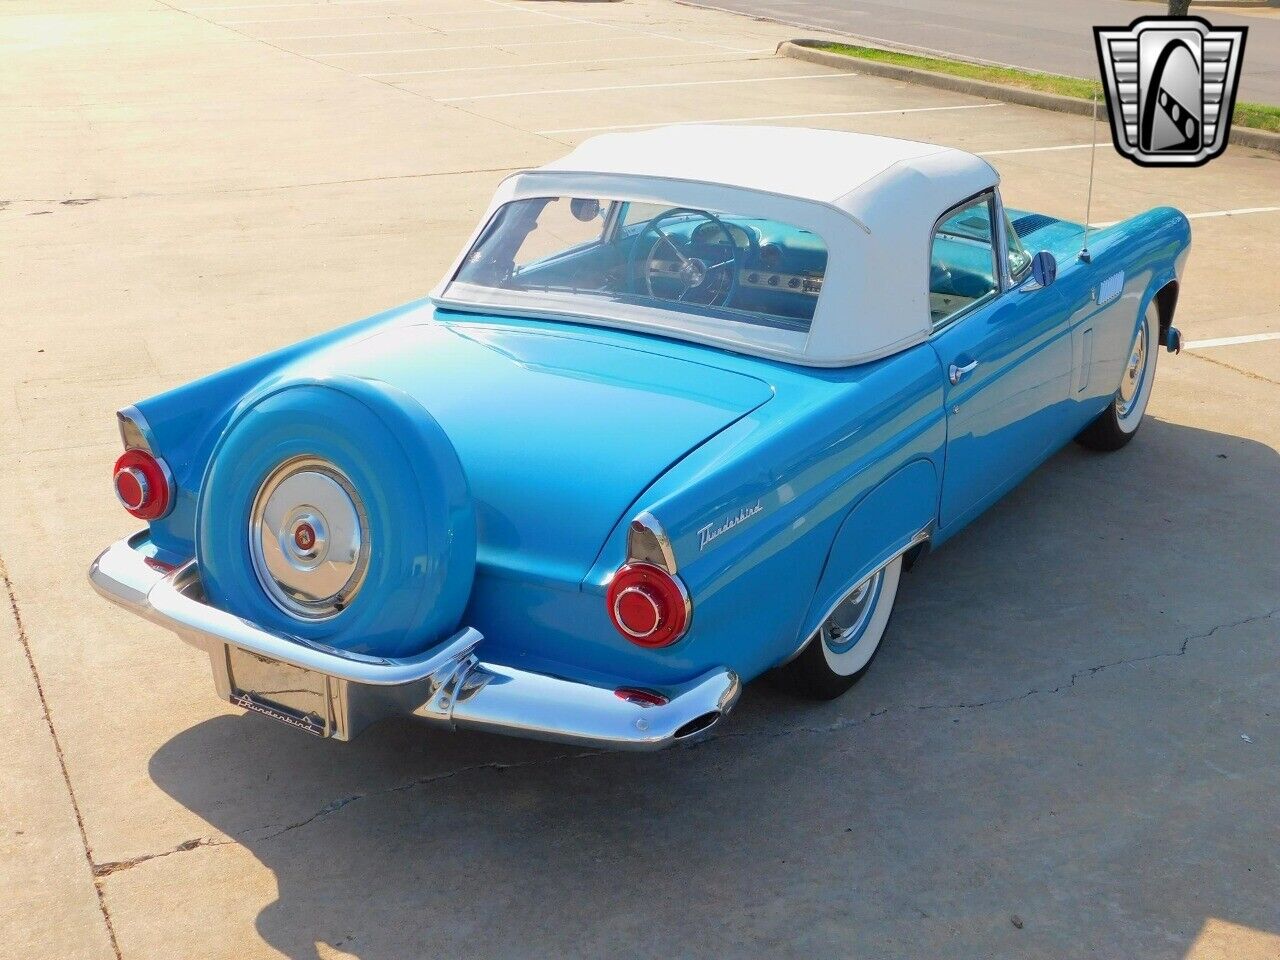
(682, 0, 1280, 104)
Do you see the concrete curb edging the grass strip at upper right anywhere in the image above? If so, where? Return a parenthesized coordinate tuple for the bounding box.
(778, 40, 1280, 154)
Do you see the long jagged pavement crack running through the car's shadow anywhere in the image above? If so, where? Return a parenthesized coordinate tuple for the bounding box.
(93, 607, 1280, 877)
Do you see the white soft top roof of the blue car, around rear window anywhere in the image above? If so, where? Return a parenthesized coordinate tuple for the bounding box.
(433, 124, 1000, 366)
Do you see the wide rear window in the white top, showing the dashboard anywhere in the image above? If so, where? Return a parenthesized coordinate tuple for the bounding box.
(444, 197, 827, 332)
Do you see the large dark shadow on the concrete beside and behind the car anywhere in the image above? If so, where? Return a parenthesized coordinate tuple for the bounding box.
(143, 419, 1280, 960)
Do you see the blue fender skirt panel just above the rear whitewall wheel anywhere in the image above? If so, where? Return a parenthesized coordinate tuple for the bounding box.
(800, 460, 941, 647)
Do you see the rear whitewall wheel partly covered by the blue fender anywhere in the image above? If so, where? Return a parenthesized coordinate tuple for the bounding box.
(776, 556, 902, 700)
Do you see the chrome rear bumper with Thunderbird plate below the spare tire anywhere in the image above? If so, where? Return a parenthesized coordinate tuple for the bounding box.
(88, 531, 741, 750)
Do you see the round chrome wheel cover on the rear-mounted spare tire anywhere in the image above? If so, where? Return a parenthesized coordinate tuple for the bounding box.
(248, 457, 369, 621)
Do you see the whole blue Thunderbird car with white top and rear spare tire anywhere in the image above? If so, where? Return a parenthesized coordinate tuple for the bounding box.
(90, 125, 1190, 749)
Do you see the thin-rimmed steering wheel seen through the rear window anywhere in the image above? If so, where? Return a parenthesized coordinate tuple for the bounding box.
(627, 206, 742, 307)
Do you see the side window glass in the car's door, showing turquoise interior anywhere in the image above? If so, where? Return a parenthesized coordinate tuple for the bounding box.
(929, 196, 1000, 326)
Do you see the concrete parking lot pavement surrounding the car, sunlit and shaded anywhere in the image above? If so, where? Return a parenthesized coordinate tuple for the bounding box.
(0, 0, 1280, 960)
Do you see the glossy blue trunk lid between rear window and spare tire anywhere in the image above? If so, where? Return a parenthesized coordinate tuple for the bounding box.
(291, 316, 773, 584)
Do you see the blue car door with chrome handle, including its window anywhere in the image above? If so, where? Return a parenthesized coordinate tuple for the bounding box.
(929, 191, 1073, 531)
